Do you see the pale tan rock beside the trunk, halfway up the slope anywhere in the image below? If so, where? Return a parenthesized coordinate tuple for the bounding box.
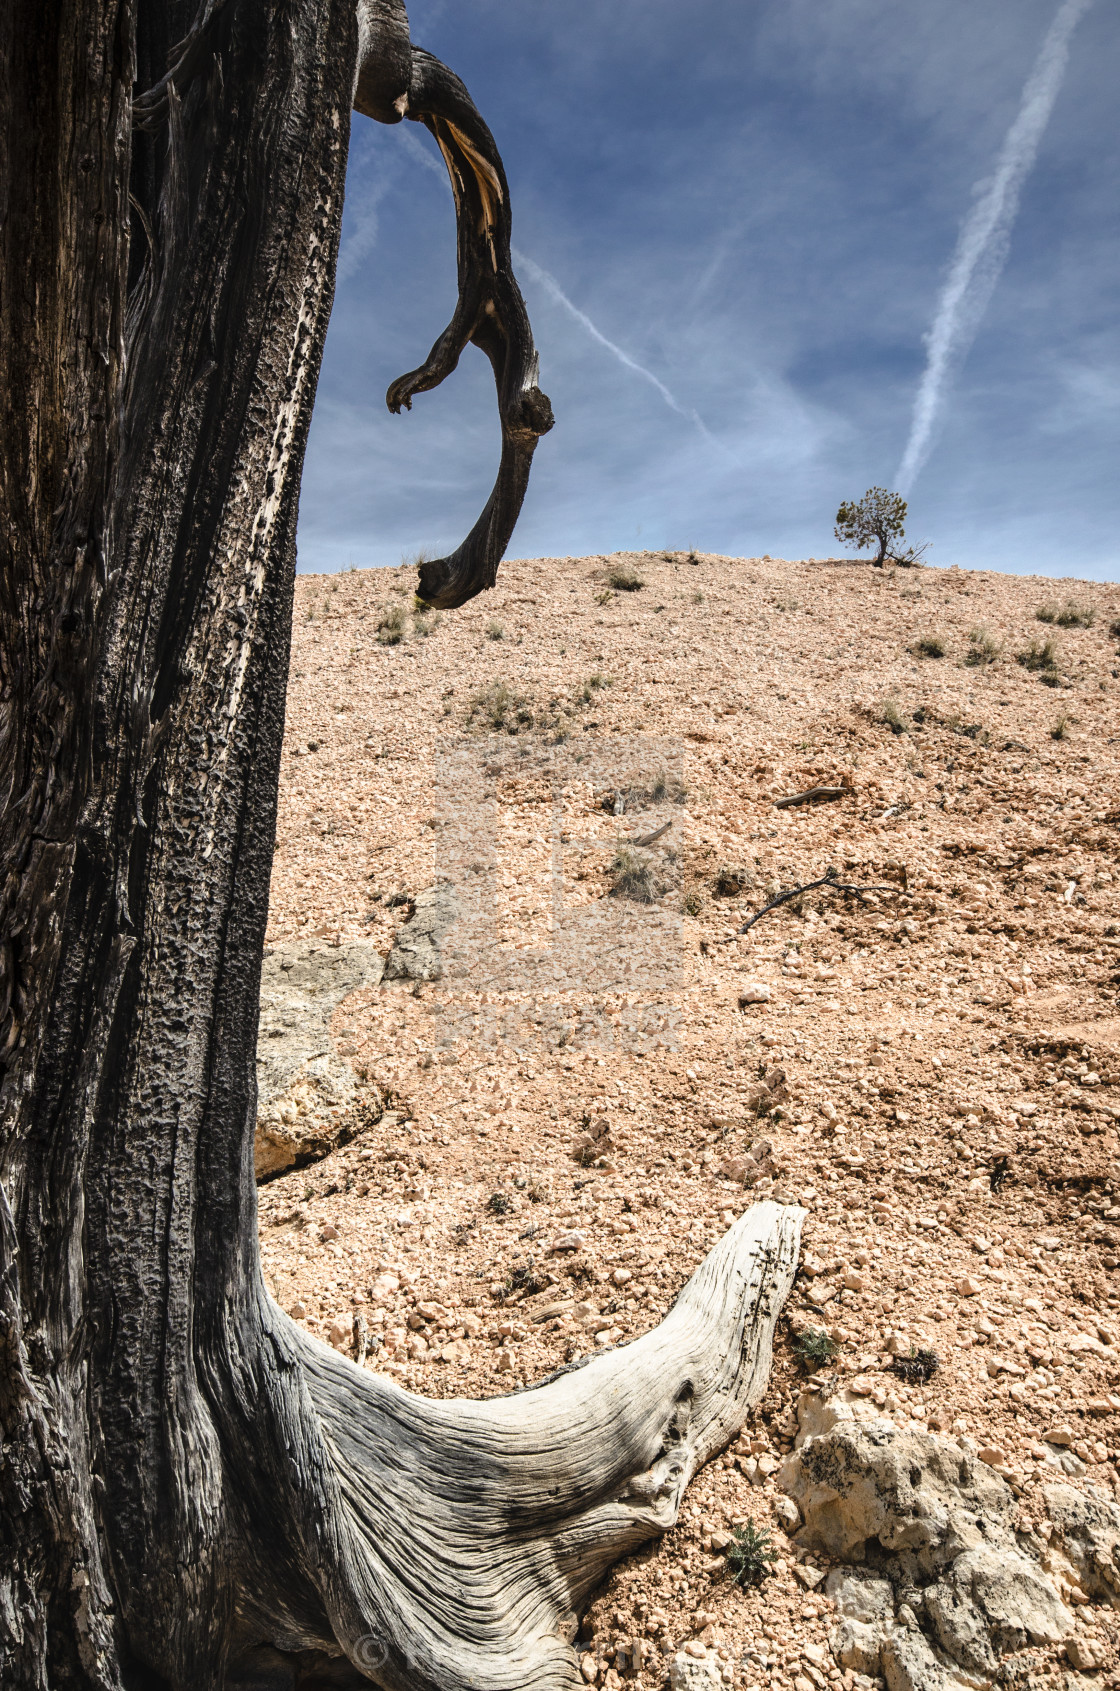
(254, 940, 382, 1180)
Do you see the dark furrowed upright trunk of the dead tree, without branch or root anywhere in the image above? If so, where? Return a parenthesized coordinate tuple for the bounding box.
(0, 0, 357, 1686)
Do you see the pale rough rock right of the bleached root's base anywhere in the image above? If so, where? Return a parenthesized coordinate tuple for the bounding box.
(782, 1395, 1082, 1691)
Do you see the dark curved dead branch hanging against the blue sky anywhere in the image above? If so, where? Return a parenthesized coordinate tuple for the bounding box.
(354, 0, 553, 609)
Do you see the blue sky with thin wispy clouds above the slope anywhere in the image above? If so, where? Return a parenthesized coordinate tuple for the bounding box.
(299, 0, 1120, 580)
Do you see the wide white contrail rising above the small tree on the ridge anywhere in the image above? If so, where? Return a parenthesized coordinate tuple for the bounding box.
(895, 0, 1093, 495)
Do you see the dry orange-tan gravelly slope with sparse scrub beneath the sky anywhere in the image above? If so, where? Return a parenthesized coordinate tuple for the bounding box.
(261, 555, 1120, 1691)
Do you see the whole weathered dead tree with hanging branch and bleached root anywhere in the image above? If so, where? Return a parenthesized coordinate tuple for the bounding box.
(0, 0, 799, 1691)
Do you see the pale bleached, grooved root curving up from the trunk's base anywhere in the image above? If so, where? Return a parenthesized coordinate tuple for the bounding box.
(243, 1202, 804, 1691)
